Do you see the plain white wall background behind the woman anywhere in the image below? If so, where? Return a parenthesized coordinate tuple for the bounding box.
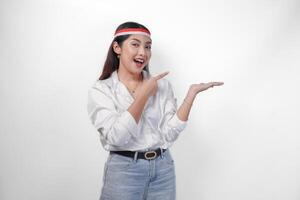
(0, 0, 300, 200)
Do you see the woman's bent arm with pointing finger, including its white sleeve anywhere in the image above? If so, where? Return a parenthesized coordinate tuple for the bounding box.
(87, 73, 167, 147)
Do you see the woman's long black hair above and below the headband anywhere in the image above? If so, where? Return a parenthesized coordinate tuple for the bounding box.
(99, 22, 149, 80)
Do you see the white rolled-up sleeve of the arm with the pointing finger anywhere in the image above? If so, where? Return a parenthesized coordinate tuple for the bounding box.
(87, 85, 137, 147)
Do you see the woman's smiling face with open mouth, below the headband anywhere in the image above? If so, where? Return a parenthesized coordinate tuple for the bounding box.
(114, 34, 151, 74)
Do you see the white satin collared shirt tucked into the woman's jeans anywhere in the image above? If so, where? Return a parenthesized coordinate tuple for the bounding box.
(87, 70, 187, 151)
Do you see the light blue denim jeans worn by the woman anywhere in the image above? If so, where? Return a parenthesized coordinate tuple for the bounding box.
(100, 150, 176, 200)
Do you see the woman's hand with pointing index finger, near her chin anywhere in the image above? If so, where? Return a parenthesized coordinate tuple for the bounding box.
(139, 72, 169, 97)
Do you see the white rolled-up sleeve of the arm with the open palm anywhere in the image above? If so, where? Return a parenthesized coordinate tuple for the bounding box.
(159, 80, 187, 142)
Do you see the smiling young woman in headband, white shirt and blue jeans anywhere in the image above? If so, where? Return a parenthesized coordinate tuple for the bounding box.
(88, 22, 223, 200)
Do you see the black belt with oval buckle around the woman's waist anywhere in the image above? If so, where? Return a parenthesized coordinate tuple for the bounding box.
(110, 149, 166, 160)
